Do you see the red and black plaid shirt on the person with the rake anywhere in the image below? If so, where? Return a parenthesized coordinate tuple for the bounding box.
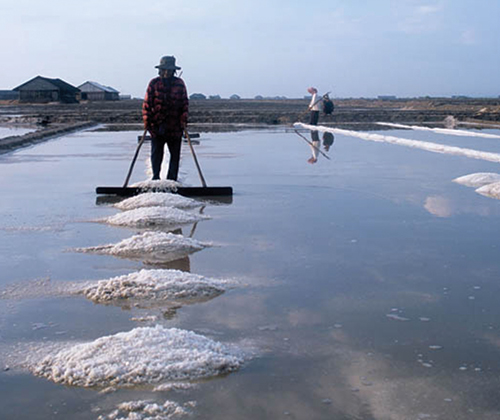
(142, 77, 189, 137)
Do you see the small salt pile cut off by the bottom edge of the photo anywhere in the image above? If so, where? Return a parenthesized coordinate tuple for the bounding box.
(97, 401, 193, 420)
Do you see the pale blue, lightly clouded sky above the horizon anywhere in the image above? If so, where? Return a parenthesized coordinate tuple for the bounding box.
(0, 0, 500, 98)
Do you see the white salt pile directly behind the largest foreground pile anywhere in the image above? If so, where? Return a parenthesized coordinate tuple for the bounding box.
(81, 270, 230, 303)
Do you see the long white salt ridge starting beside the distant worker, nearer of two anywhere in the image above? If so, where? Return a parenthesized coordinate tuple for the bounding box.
(293, 123, 500, 163)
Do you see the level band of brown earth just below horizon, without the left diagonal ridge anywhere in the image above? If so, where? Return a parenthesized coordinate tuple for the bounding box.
(0, 98, 500, 125)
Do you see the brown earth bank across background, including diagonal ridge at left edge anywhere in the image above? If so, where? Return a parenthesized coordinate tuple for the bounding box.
(0, 98, 500, 151)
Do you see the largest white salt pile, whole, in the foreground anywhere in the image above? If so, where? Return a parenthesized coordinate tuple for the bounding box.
(31, 325, 243, 387)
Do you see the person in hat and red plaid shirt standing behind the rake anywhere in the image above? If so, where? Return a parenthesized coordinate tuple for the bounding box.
(142, 56, 189, 181)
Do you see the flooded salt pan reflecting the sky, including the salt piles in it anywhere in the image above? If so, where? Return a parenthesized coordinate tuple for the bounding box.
(0, 128, 500, 420)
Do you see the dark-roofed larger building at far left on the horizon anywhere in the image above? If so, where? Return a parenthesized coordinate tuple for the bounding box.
(13, 76, 80, 103)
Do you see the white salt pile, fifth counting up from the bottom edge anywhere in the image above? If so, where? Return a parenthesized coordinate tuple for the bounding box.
(100, 207, 209, 227)
